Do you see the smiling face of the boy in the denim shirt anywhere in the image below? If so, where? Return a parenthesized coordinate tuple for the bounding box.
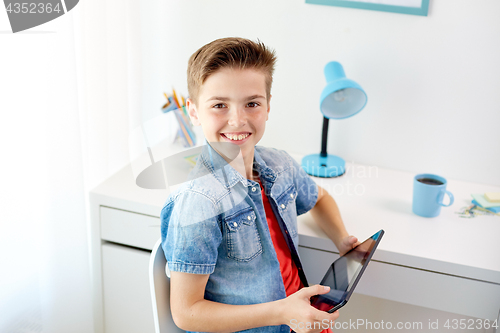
(187, 68, 269, 157)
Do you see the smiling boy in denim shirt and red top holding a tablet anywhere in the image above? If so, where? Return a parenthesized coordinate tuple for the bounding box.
(161, 38, 357, 332)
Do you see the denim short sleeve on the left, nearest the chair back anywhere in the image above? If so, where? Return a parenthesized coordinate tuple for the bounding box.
(161, 191, 222, 274)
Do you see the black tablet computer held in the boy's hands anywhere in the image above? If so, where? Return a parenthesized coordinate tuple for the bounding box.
(311, 230, 384, 313)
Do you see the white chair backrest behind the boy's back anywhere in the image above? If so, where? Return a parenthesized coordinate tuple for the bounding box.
(149, 239, 184, 333)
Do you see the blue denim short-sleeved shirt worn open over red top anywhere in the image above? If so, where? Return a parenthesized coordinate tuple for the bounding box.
(161, 145, 318, 333)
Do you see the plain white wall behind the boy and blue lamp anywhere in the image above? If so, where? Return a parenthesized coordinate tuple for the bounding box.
(141, 0, 500, 185)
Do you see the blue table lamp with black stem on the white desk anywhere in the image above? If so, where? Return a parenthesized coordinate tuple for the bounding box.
(302, 61, 367, 178)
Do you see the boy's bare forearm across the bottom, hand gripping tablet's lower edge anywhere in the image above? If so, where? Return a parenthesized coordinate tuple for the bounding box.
(170, 271, 338, 332)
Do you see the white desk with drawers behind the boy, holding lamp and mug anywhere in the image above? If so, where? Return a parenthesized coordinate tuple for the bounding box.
(90, 156, 500, 333)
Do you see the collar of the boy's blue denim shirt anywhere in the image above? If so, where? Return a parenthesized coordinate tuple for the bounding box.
(200, 143, 276, 188)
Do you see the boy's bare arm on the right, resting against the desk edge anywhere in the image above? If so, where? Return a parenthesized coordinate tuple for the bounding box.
(311, 186, 359, 255)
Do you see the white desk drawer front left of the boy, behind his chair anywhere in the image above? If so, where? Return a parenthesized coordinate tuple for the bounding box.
(100, 206, 160, 250)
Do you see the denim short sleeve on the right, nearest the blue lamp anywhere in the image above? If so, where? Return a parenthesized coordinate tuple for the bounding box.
(287, 153, 318, 215)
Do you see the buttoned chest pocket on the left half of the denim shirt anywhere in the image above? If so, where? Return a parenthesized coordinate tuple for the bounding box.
(224, 207, 262, 261)
